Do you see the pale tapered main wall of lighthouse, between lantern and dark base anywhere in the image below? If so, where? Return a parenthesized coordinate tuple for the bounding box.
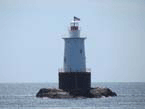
(64, 38, 86, 72)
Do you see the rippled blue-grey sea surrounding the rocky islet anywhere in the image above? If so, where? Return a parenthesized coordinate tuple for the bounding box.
(0, 83, 145, 109)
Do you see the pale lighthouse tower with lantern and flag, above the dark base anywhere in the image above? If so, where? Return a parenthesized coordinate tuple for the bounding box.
(63, 17, 86, 72)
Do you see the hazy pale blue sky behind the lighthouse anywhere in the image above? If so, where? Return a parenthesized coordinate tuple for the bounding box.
(0, 0, 145, 83)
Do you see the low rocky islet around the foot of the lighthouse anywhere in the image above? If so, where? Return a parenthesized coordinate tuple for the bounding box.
(36, 87, 117, 98)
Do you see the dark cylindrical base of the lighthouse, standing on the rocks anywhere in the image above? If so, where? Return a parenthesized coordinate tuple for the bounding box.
(59, 72, 91, 95)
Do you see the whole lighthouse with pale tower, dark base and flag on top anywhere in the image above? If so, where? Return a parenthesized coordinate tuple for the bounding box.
(59, 17, 91, 95)
